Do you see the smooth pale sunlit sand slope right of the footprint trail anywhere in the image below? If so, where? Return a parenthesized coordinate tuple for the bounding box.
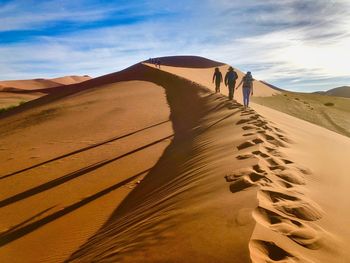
(253, 105, 350, 263)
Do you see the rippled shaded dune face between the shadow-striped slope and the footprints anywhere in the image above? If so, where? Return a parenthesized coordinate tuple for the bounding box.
(67, 61, 255, 262)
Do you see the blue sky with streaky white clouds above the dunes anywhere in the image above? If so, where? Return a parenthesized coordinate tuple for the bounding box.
(0, 0, 350, 92)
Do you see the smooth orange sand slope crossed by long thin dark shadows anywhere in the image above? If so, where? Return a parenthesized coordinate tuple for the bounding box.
(0, 81, 173, 262)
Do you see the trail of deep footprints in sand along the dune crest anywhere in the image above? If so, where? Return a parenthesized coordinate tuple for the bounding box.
(225, 110, 323, 263)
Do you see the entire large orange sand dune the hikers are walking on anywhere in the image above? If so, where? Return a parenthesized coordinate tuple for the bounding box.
(0, 57, 350, 263)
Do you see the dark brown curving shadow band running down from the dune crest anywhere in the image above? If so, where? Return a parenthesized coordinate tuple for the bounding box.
(66, 65, 241, 262)
